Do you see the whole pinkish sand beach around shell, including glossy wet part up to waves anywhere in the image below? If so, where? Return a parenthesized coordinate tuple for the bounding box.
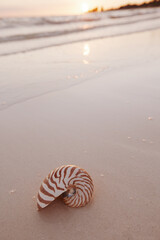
(0, 27, 160, 240)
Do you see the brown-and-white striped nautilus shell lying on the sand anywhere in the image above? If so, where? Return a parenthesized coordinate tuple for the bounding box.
(37, 165, 93, 210)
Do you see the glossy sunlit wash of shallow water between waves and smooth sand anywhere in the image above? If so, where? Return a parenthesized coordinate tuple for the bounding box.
(0, 29, 160, 111)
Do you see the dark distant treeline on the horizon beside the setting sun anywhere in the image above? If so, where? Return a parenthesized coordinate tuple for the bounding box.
(88, 0, 160, 12)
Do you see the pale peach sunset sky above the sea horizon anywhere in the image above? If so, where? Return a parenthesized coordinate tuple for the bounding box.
(0, 0, 150, 17)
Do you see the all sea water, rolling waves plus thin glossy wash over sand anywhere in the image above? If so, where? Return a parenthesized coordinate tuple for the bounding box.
(0, 8, 160, 110)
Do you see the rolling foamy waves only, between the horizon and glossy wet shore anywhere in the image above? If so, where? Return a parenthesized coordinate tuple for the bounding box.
(0, 8, 160, 56)
